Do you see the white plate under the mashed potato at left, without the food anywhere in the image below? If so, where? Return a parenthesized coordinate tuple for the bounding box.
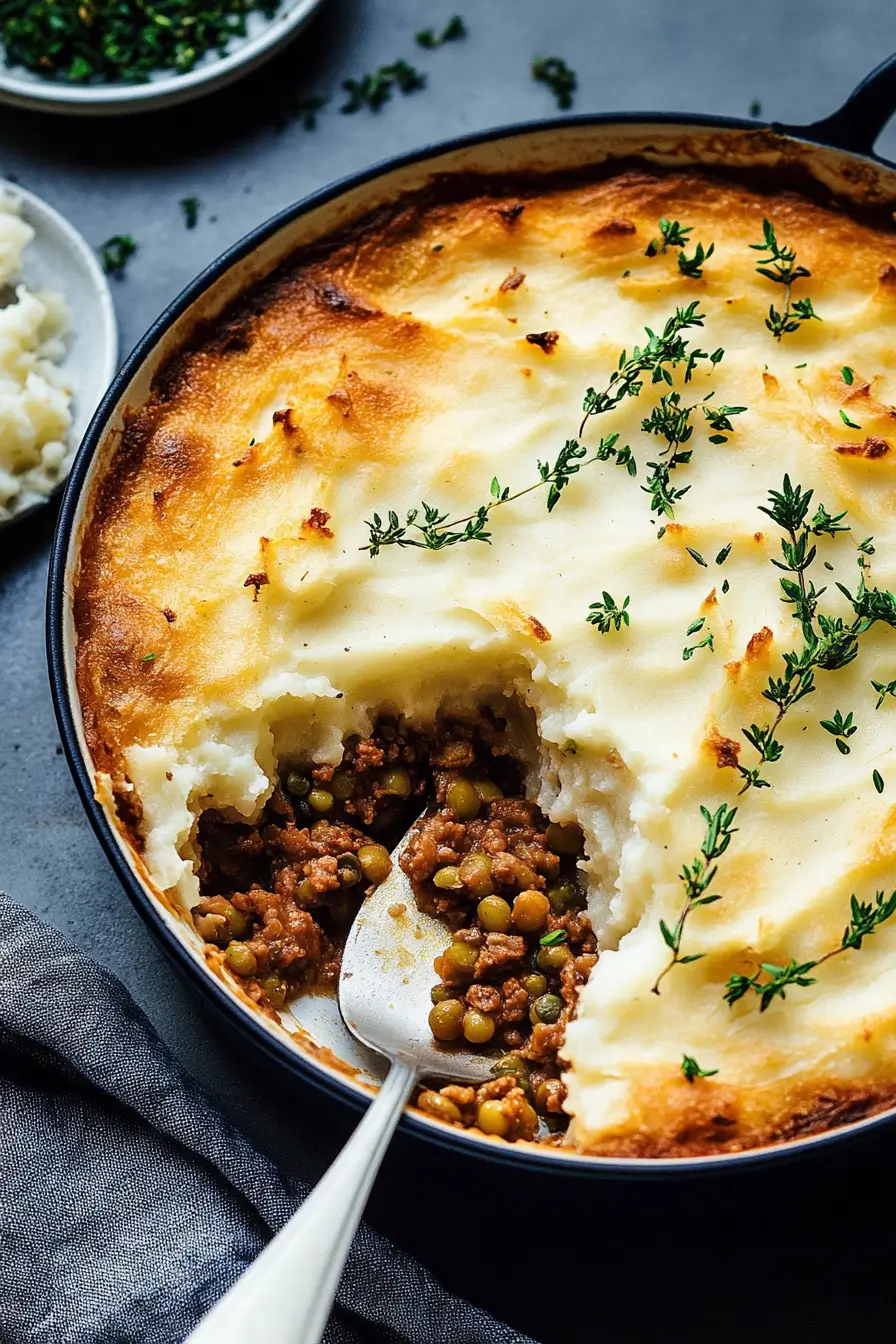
(0, 183, 118, 530)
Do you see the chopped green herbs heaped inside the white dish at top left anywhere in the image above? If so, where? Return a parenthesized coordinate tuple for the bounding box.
(0, 0, 278, 83)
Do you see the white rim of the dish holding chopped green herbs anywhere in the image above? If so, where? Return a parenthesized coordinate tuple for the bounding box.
(0, 0, 324, 117)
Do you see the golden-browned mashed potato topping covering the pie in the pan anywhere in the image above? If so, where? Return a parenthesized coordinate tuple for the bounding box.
(77, 171, 896, 1156)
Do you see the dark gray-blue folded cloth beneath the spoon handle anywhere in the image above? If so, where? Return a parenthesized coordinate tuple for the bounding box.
(0, 896, 531, 1344)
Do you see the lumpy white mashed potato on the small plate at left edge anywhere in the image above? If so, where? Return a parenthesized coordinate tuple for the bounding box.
(0, 192, 71, 521)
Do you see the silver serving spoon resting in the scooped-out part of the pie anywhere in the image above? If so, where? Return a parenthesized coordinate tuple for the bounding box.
(185, 835, 492, 1344)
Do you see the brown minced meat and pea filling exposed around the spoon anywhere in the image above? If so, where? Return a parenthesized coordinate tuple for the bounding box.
(193, 715, 596, 1138)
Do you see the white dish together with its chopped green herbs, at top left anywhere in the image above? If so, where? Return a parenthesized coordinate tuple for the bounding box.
(0, 0, 322, 116)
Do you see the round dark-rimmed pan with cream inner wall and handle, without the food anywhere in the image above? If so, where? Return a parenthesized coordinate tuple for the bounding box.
(47, 55, 896, 1177)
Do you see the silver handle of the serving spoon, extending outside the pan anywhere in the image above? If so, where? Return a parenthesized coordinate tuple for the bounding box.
(185, 1063, 416, 1344)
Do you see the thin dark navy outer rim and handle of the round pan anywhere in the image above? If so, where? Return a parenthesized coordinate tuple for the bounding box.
(47, 55, 896, 1179)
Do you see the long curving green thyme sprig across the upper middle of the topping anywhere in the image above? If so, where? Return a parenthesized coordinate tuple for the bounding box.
(361, 302, 723, 556)
